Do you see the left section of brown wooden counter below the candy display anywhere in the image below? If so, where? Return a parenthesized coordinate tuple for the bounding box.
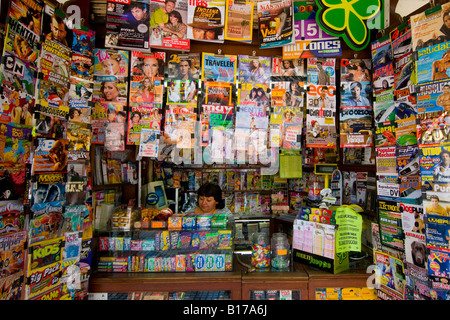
(89, 270, 241, 300)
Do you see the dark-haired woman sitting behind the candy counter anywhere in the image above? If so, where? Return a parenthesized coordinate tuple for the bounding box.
(187, 183, 231, 215)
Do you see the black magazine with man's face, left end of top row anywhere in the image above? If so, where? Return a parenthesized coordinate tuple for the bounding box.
(105, 0, 150, 51)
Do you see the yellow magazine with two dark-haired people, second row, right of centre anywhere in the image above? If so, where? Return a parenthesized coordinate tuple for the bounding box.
(237, 82, 270, 110)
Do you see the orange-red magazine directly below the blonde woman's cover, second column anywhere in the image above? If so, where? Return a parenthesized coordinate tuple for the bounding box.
(129, 76, 164, 105)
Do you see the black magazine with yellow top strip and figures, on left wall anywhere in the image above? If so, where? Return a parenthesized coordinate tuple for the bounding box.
(34, 100, 70, 138)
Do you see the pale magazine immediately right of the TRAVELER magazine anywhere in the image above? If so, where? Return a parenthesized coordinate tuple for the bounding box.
(238, 55, 271, 84)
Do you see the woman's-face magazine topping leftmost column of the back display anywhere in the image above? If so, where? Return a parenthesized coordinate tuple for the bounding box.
(94, 48, 129, 77)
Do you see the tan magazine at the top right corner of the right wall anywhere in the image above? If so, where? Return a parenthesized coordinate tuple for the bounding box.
(410, 3, 450, 51)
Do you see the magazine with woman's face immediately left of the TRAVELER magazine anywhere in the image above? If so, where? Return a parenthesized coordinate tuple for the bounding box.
(167, 52, 200, 80)
